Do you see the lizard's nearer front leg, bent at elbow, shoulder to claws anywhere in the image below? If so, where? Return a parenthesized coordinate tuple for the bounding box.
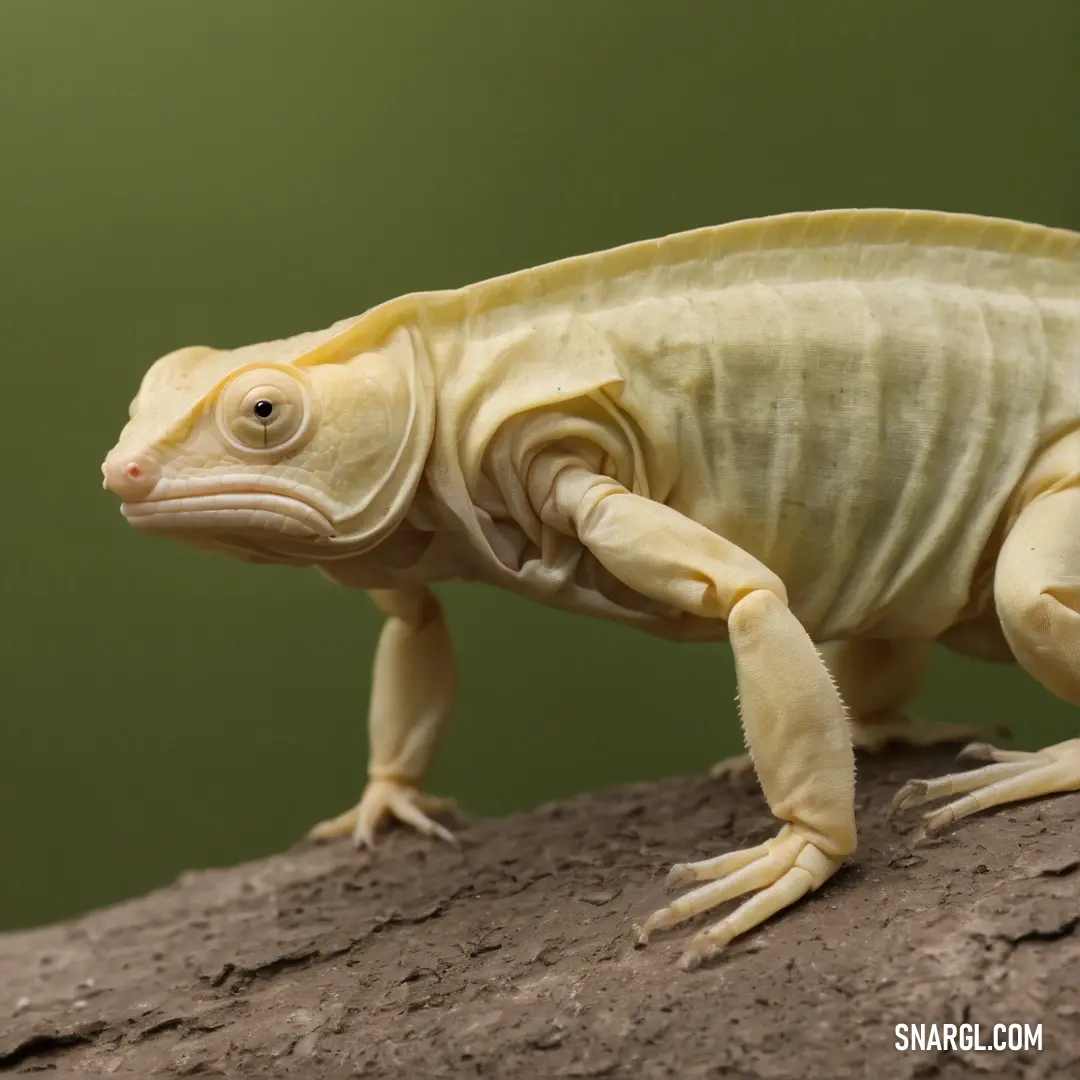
(529, 462, 855, 967)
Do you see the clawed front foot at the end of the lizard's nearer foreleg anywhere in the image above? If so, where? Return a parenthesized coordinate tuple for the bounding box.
(635, 825, 843, 970)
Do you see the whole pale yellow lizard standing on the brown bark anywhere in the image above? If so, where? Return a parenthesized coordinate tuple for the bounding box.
(103, 210, 1080, 968)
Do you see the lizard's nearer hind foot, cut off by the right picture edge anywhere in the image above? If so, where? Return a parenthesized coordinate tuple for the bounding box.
(889, 739, 1080, 833)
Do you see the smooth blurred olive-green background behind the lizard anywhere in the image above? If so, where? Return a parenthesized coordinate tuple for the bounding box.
(0, 0, 1080, 927)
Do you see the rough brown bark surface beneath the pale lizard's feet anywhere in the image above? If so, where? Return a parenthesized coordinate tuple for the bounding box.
(0, 752, 1080, 1080)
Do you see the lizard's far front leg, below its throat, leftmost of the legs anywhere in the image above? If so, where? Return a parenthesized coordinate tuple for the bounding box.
(309, 585, 457, 846)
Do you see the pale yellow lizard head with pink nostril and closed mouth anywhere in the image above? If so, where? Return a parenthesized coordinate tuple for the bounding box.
(102, 318, 434, 564)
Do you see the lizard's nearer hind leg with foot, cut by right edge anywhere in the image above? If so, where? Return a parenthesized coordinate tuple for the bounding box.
(892, 479, 1080, 832)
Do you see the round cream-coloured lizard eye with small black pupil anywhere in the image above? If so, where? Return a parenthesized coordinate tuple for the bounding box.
(217, 367, 311, 453)
